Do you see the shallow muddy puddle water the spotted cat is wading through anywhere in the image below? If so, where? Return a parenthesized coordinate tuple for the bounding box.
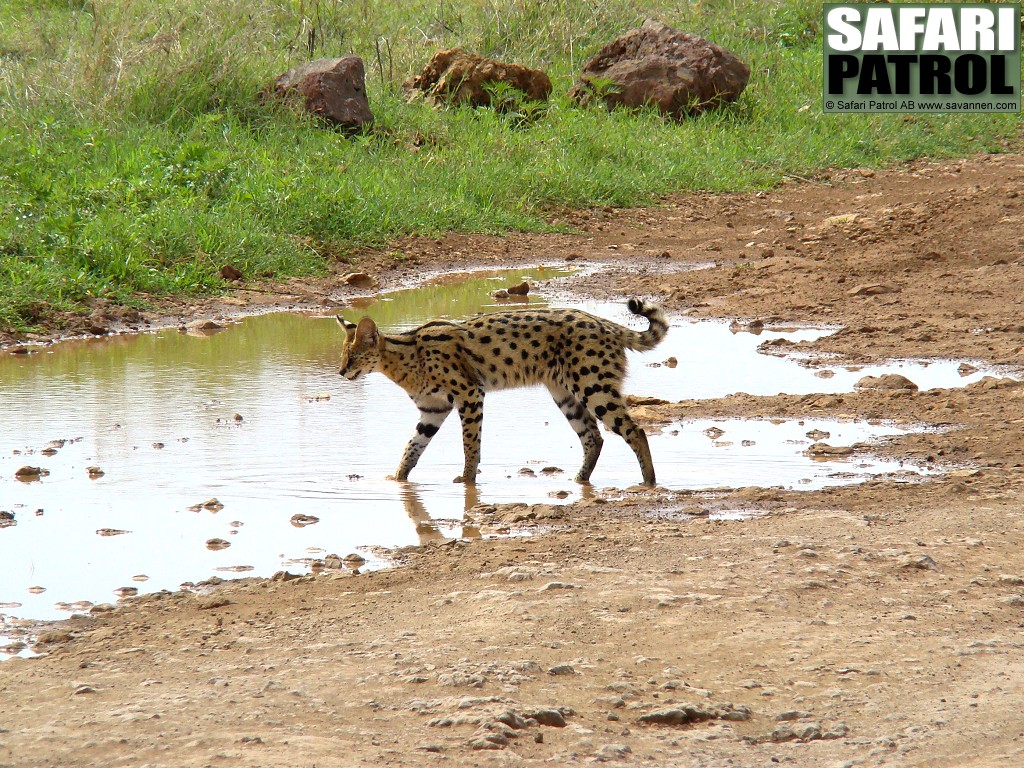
(0, 270, 980, 645)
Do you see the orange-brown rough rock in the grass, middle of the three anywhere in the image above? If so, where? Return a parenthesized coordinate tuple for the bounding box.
(406, 48, 551, 106)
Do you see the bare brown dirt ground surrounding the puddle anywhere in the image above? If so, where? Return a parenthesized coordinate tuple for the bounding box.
(0, 155, 1024, 768)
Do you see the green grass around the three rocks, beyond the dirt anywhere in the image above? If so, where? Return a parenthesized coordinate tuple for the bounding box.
(0, 0, 1021, 330)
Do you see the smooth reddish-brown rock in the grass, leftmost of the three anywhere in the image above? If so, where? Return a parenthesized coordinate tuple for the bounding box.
(271, 56, 374, 131)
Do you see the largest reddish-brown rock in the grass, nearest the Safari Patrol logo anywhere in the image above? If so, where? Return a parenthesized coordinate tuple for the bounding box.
(569, 20, 751, 119)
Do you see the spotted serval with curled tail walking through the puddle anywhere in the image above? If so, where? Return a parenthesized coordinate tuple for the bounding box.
(338, 299, 669, 485)
